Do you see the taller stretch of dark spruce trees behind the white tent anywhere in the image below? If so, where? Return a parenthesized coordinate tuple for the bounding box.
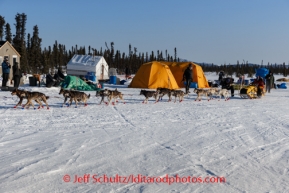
(0, 13, 179, 73)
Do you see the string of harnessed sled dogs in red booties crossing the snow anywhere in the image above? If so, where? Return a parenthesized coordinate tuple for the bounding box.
(11, 85, 229, 109)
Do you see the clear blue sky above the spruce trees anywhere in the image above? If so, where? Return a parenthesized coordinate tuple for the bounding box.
(0, 0, 289, 64)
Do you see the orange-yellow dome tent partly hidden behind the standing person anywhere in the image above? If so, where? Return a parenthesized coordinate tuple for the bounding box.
(162, 62, 209, 88)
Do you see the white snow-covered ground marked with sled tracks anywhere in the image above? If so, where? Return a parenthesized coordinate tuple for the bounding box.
(0, 74, 289, 193)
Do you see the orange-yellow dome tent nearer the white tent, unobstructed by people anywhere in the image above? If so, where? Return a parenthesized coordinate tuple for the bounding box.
(129, 61, 179, 89)
